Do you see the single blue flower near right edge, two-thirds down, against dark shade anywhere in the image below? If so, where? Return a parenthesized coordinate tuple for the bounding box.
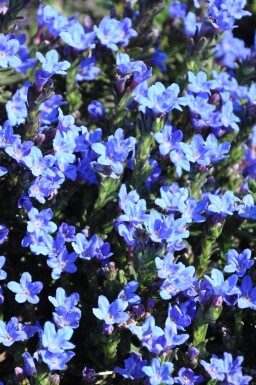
(224, 249, 254, 277)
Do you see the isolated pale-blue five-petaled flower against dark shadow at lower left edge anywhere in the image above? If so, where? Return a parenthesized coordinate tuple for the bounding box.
(7, 272, 43, 304)
